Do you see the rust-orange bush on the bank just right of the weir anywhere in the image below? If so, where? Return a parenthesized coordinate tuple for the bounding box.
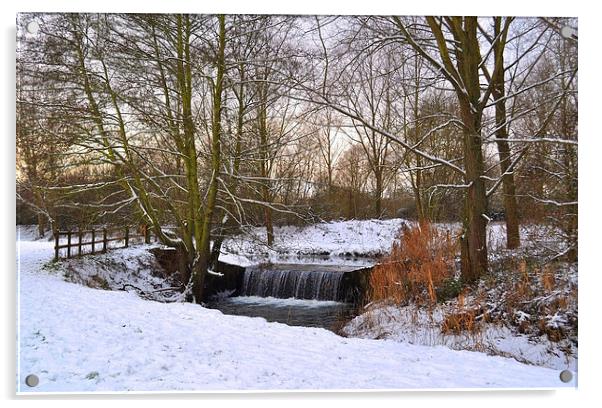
(370, 222, 456, 304)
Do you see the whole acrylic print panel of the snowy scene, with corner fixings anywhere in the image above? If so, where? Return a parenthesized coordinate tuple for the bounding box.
(16, 13, 578, 393)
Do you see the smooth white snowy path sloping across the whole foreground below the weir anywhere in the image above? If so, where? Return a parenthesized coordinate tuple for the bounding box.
(17, 241, 574, 392)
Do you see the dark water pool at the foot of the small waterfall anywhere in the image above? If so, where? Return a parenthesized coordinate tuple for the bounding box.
(208, 296, 354, 330)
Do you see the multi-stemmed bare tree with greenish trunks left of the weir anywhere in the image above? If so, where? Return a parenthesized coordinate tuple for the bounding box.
(18, 14, 226, 301)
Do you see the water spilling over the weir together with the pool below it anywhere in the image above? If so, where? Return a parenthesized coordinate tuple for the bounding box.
(209, 264, 364, 330)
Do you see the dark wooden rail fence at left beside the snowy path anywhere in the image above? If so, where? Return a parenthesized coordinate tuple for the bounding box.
(54, 226, 156, 261)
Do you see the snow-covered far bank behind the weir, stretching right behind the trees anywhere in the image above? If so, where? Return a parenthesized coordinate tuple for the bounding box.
(220, 218, 564, 266)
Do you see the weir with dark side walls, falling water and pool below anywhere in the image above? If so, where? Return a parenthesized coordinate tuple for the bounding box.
(152, 248, 372, 331)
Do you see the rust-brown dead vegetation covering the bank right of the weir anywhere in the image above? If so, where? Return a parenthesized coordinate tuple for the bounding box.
(354, 223, 578, 361)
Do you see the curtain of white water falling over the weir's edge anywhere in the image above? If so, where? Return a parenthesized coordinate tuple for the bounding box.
(241, 267, 344, 300)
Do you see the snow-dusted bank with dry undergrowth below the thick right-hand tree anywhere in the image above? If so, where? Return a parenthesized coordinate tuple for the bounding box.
(341, 222, 578, 371)
